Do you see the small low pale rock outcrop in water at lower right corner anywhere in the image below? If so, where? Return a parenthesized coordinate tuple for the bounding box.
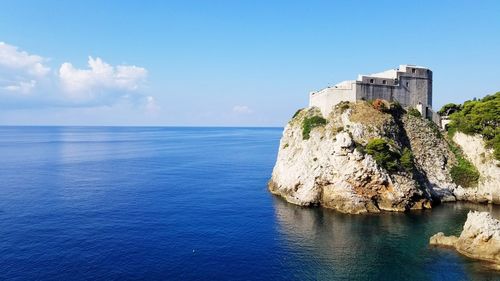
(429, 211, 500, 265)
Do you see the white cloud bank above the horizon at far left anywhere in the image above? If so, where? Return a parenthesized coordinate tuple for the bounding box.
(0, 42, 152, 109)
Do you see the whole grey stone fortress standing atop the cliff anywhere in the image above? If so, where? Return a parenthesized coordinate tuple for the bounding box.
(309, 65, 440, 124)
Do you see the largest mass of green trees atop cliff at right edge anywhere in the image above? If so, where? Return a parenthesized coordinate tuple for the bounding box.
(446, 92, 500, 160)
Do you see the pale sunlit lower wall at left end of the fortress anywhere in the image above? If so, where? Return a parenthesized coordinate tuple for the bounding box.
(309, 87, 356, 117)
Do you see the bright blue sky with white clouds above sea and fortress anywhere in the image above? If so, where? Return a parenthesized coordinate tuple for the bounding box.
(0, 0, 500, 126)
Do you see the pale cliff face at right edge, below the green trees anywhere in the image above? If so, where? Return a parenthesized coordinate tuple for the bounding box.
(453, 132, 500, 204)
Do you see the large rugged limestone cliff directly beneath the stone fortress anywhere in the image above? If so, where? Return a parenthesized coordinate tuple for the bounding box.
(269, 102, 455, 213)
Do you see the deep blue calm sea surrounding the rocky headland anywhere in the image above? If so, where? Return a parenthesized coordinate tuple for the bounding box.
(0, 127, 500, 280)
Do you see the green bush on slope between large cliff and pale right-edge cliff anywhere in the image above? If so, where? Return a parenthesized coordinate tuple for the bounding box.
(449, 142, 479, 187)
